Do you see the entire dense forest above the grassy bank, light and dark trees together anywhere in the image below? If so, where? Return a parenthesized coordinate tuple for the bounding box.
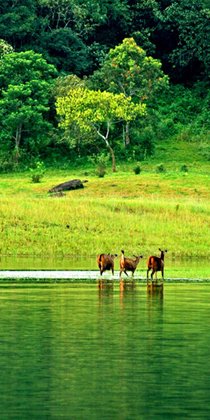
(0, 0, 210, 171)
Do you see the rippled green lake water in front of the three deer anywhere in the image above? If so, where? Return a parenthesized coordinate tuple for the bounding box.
(0, 281, 210, 420)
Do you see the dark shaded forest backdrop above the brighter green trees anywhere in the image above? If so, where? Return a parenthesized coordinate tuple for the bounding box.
(0, 0, 210, 84)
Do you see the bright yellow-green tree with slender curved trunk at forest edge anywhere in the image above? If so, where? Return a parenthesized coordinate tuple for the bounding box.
(56, 87, 146, 172)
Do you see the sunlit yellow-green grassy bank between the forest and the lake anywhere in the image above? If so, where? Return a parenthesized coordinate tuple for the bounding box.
(0, 139, 210, 266)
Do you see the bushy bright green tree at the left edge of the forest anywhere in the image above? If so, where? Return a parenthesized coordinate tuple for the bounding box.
(0, 51, 56, 166)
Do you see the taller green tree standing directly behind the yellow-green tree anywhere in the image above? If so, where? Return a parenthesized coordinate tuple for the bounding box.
(90, 38, 168, 144)
